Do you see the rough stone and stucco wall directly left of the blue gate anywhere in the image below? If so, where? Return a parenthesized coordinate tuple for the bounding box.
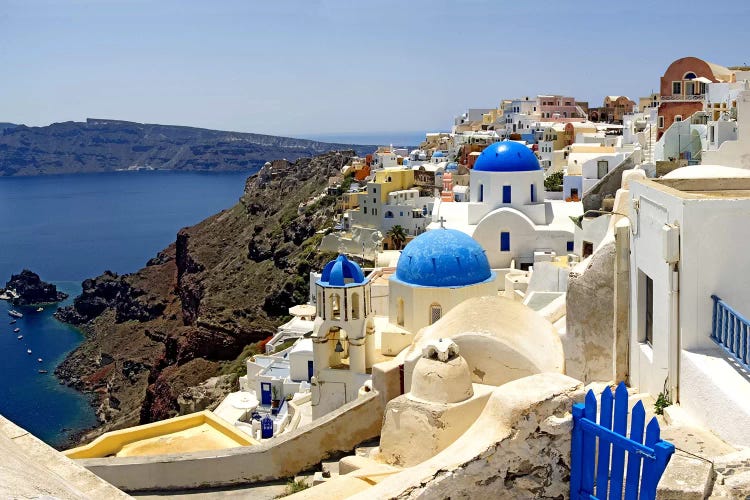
(352, 373, 584, 500)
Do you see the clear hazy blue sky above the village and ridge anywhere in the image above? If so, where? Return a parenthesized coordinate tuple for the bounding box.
(0, 0, 750, 135)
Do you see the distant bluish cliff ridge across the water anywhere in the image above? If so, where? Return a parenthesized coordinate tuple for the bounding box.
(0, 118, 376, 177)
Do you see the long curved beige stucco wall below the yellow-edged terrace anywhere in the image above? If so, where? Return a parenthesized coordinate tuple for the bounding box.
(77, 392, 383, 491)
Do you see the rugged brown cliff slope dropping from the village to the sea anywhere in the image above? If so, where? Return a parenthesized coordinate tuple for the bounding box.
(56, 151, 354, 439)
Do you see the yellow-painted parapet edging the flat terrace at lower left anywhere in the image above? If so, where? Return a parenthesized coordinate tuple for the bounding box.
(64, 410, 258, 458)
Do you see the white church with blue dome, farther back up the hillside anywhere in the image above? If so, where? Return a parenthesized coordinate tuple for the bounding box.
(428, 141, 583, 269)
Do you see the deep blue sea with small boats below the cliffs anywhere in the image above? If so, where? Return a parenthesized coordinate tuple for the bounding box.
(0, 171, 253, 447)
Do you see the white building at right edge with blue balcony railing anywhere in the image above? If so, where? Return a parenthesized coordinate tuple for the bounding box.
(630, 165, 750, 446)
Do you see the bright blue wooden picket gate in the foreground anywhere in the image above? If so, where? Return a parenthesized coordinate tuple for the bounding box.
(570, 382, 674, 500)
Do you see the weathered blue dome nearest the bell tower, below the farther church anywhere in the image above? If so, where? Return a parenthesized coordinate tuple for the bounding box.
(391, 229, 494, 287)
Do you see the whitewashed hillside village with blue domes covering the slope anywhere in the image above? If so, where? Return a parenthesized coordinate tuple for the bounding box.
(5, 57, 750, 498)
